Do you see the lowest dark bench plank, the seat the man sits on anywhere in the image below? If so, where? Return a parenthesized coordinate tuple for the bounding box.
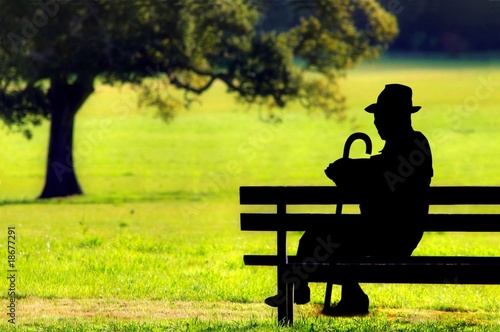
(244, 255, 500, 284)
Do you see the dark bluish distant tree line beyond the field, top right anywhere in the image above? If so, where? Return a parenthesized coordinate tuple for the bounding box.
(260, 0, 500, 56)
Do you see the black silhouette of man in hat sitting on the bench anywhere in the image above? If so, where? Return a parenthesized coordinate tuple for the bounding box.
(265, 84, 433, 316)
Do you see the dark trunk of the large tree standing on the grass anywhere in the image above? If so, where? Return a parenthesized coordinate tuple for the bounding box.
(39, 78, 94, 198)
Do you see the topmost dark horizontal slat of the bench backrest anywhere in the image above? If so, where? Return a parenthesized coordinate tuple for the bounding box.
(240, 186, 500, 205)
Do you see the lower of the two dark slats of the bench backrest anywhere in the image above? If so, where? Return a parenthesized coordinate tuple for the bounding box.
(240, 213, 500, 232)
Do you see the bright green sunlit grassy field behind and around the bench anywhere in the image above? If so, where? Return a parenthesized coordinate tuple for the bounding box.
(0, 55, 500, 331)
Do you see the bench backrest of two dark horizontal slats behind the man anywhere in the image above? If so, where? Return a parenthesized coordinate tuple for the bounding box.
(240, 186, 500, 232)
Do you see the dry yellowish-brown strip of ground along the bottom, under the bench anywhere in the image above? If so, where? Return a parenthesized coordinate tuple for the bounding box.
(2, 297, 500, 327)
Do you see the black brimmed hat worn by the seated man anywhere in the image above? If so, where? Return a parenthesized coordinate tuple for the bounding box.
(365, 84, 421, 113)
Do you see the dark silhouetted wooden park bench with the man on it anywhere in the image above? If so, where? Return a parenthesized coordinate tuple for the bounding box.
(240, 186, 500, 324)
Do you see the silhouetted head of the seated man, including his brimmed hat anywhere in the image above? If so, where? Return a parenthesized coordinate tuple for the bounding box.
(365, 84, 421, 140)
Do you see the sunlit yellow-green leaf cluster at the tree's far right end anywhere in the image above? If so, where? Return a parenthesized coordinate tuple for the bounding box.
(283, 0, 398, 118)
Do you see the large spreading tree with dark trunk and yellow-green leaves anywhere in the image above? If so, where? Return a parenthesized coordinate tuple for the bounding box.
(0, 0, 397, 198)
